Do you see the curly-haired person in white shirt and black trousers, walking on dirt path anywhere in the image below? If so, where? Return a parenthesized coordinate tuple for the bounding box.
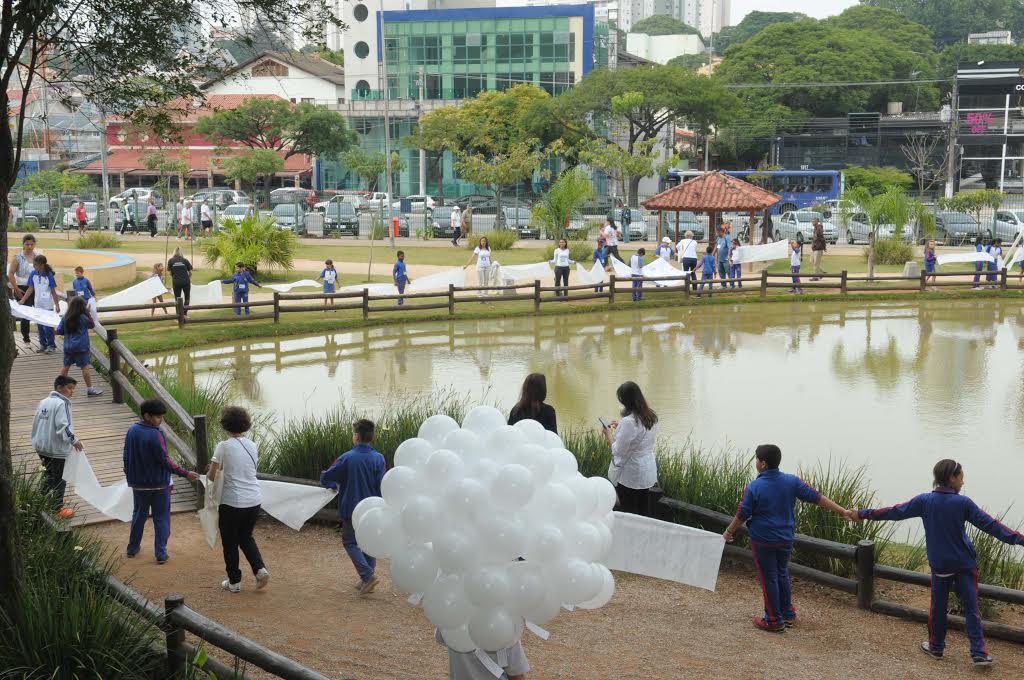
(208, 407, 270, 593)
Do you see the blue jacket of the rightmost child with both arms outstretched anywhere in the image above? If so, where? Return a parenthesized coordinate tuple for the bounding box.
(859, 486, 1024, 573)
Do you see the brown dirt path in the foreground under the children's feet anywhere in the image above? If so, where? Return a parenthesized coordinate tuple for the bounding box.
(87, 514, 1024, 680)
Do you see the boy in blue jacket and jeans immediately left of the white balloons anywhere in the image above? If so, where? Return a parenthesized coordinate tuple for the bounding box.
(321, 419, 386, 596)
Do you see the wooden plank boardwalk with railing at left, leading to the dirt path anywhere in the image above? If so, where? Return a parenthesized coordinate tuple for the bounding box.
(10, 328, 196, 524)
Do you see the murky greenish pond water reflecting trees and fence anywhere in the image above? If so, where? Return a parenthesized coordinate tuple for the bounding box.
(147, 300, 1024, 523)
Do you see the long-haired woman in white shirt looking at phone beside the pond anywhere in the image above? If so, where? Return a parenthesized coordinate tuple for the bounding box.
(603, 381, 657, 514)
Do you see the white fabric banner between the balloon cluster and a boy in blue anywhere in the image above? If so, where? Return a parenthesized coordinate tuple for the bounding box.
(604, 512, 725, 591)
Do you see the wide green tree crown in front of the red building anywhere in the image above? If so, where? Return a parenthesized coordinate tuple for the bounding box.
(195, 97, 355, 159)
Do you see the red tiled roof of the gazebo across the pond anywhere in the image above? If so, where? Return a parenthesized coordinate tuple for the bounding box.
(643, 172, 781, 212)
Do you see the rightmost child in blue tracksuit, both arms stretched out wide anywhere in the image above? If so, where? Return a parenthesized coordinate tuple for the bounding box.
(848, 459, 1024, 666)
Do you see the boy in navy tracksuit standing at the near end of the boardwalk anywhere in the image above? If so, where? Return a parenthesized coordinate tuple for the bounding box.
(123, 399, 199, 564)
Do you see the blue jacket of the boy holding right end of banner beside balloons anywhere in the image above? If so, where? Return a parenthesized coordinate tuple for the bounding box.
(736, 469, 821, 545)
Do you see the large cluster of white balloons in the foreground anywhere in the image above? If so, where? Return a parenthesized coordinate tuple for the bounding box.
(352, 407, 615, 652)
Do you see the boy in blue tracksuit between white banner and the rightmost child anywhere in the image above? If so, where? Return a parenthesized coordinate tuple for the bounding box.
(722, 443, 847, 633)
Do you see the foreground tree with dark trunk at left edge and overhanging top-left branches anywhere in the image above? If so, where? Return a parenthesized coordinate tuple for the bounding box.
(0, 0, 343, 621)
